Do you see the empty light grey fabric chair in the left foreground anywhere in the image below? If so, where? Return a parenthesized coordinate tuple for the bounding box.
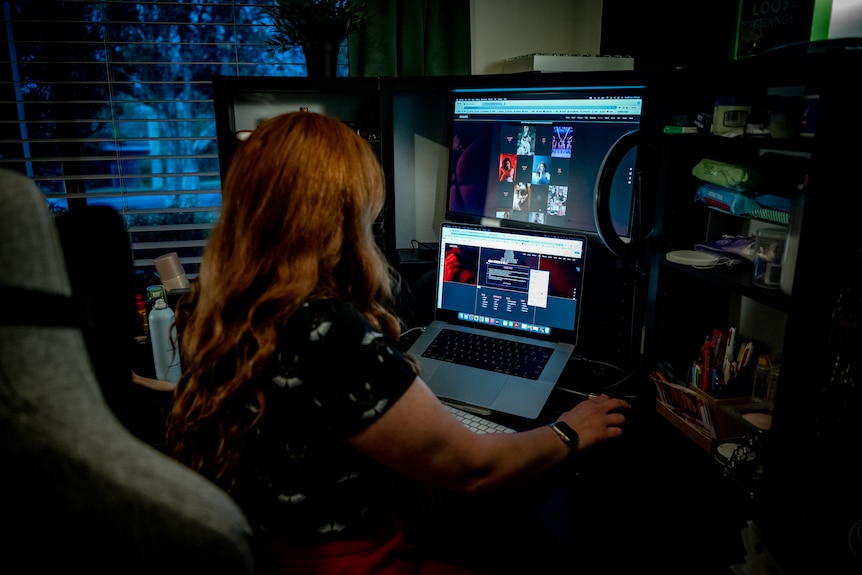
(0, 170, 254, 575)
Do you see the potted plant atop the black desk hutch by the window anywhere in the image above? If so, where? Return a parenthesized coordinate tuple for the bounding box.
(265, 0, 368, 76)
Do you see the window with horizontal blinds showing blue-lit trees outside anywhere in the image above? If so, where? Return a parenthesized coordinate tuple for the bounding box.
(0, 0, 347, 277)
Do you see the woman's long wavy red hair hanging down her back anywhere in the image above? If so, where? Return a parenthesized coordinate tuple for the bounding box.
(168, 112, 410, 489)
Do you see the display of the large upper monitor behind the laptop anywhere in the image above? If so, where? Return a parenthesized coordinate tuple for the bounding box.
(447, 86, 644, 237)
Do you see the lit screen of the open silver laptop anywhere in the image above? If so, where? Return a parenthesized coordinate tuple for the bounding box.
(436, 222, 587, 344)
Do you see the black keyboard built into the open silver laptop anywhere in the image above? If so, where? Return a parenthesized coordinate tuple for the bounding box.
(422, 329, 553, 379)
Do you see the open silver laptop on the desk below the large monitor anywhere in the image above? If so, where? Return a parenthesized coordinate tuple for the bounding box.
(409, 221, 587, 419)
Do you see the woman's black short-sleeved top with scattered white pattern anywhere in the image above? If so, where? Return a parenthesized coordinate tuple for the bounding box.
(232, 300, 415, 542)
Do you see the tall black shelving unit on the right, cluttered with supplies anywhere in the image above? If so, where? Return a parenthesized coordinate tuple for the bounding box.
(645, 45, 862, 573)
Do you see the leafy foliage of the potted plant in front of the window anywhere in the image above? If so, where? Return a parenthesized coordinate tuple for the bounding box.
(265, 0, 368, 51)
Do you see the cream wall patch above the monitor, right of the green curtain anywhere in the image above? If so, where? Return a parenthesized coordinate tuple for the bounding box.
(470, 0, 612, 74)
